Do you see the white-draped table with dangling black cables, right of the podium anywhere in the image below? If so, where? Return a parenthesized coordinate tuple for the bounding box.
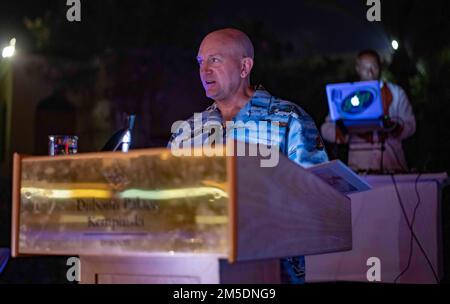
(306, 173, 447, 283)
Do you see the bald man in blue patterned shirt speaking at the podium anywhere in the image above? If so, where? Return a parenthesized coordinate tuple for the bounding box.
(169, 28, 328, 283)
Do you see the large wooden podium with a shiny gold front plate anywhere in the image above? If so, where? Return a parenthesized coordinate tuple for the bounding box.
(11, 149, 352, 283)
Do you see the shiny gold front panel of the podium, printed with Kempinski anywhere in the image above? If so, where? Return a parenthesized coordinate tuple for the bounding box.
(13, 149, 229, 257)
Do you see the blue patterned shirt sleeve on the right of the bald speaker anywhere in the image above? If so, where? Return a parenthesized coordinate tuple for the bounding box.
(287, 112, 328, 168)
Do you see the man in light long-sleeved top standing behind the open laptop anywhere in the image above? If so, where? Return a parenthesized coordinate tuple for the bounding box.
(321, 50, 416, 172)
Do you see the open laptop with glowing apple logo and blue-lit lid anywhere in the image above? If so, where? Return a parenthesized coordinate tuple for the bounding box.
(326, 80, 384, 132)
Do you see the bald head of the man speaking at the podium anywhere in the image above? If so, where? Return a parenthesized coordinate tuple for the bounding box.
(197, 28, 254, 101)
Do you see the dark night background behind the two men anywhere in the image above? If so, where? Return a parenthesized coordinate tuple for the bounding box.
(0, 0, 450, 282)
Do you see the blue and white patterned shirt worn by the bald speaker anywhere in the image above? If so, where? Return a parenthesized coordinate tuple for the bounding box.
(169, 86, 328, 283)
